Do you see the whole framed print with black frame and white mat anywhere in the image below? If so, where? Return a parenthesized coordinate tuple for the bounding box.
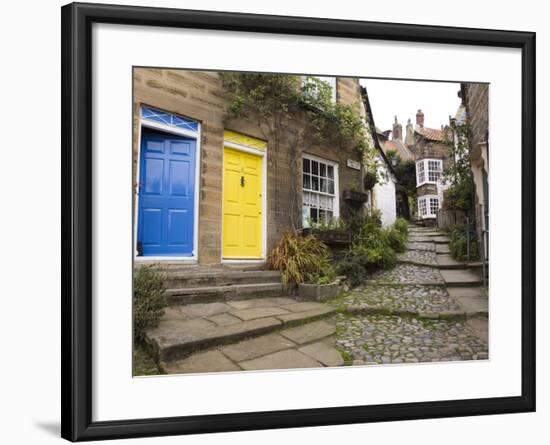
(62, 3, 535, 441)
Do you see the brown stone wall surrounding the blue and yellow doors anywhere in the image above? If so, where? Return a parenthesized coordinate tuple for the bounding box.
(133, 68, 364, 264)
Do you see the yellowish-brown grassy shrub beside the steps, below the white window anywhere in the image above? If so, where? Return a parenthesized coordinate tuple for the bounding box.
(266, 233, 329, 288)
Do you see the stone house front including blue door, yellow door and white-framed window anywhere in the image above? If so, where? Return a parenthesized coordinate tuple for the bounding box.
(133, 68, 380, 265)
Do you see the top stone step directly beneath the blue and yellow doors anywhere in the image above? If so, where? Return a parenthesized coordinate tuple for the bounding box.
(165, 270, 281, 289)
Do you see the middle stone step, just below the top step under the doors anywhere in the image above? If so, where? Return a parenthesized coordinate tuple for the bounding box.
(166, 282, 286, 305)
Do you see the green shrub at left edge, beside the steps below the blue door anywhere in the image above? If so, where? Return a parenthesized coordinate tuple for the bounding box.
(133, 266, 167, 340)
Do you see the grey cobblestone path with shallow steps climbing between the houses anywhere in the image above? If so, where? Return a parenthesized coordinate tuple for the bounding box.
(332, 227, 489, 365)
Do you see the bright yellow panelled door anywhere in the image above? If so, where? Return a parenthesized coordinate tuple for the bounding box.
(222, 147, 262, 258)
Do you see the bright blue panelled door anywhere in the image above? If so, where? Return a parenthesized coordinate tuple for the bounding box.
(138, 128, 196, 256)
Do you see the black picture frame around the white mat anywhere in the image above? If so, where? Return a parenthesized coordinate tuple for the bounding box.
(61, 3, 536, 441)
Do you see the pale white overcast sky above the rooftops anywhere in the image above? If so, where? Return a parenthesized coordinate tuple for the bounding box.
(361, 79, 460, 136)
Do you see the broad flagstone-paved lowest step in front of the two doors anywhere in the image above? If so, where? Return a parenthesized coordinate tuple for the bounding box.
(146, 298, 335, 362)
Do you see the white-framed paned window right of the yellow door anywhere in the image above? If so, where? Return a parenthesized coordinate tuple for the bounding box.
(302, 156, 339, 227)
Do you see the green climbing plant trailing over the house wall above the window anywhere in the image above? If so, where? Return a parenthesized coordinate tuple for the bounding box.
(220, 73, 380, 229)
